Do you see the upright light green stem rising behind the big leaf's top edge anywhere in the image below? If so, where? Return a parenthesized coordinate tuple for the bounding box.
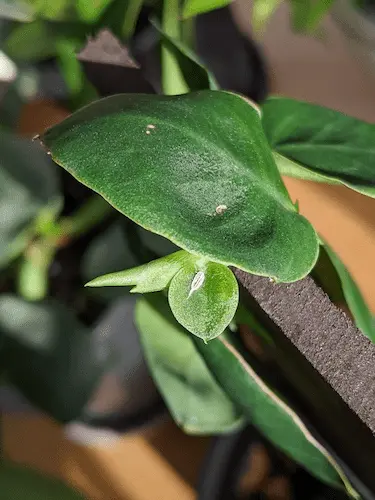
(161, 0, 189, 95)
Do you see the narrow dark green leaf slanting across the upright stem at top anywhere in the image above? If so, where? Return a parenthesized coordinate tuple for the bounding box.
(152, 20, 219, 91)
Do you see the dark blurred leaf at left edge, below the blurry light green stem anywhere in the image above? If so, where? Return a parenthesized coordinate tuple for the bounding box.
(0, 295, 106, 422)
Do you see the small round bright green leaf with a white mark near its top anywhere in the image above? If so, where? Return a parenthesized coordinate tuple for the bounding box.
(168, 261, 238, 341)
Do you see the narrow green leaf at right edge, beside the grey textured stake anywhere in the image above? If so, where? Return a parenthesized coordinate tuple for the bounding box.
(322, 242, 375, 343)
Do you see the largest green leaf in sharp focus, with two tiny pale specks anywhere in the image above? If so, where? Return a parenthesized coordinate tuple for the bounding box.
(41, 91, 318, 282)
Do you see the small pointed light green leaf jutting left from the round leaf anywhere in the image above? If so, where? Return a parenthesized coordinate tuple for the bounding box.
(85, 250, 192, 293)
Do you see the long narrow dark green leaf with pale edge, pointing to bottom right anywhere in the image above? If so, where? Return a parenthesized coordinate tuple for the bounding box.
(197, 336, 358, 498)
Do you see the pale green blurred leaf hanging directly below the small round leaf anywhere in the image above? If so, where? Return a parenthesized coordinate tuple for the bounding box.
(135, 294, 242, 434)
